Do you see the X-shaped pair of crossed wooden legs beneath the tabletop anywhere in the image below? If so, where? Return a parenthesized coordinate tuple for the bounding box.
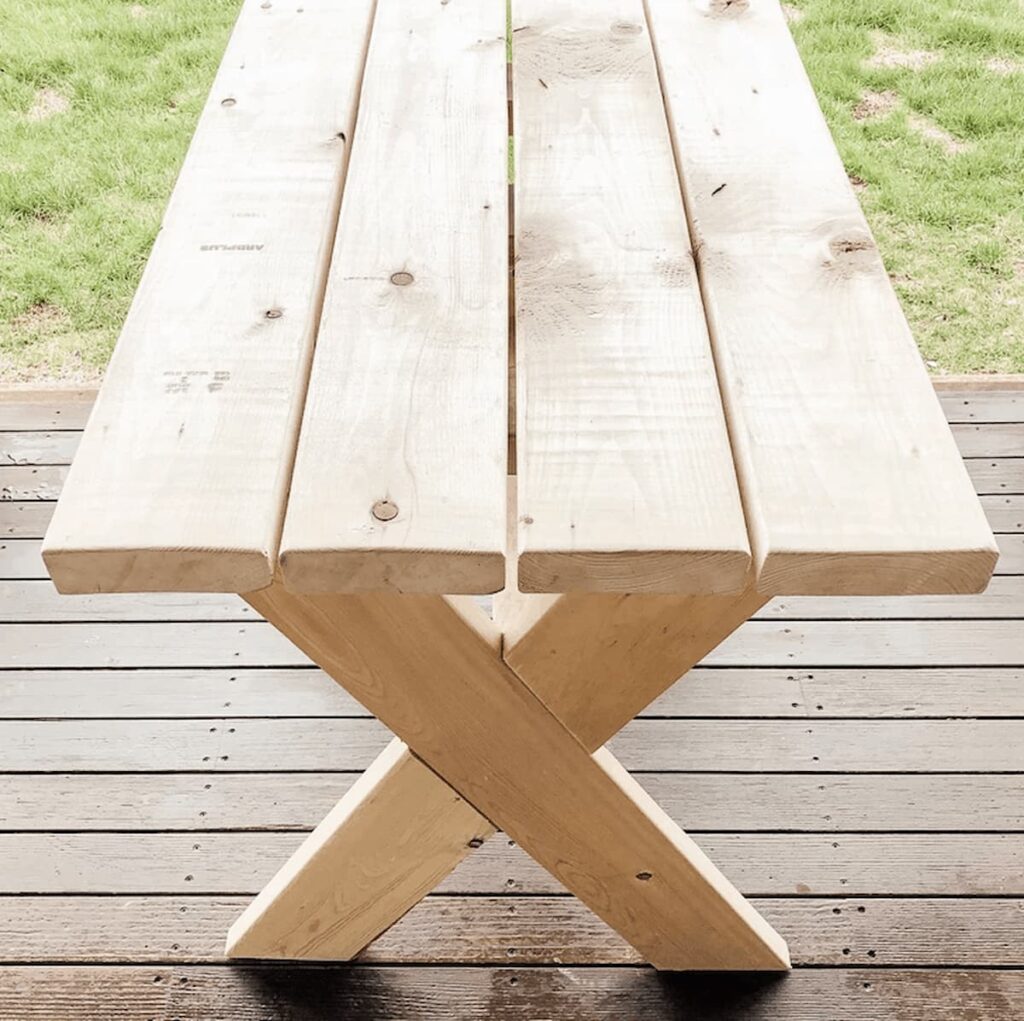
(222, 585, 788, 970)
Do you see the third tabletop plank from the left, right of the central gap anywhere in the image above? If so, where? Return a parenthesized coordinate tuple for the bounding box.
(512, 0, 750, 594)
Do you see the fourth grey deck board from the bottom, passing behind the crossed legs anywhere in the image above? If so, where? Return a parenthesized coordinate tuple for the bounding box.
(0, 772, 1024, 839)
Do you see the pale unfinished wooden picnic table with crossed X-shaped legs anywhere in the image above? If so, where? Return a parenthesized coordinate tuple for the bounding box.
(44, 0, 997, 970)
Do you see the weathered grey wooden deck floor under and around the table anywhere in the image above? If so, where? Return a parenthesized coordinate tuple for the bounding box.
(0, 391, 1024, 1021)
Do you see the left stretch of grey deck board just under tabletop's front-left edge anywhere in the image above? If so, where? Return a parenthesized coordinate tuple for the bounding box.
(0, 581, 259, 624)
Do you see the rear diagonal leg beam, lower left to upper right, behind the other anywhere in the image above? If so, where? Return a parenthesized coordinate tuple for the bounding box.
(227, 581, 764, 960)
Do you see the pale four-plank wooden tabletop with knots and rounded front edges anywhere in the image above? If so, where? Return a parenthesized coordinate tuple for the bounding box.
(44, 0, 997, 594)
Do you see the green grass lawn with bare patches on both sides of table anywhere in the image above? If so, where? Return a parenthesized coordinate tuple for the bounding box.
(0, 0, 1024, 384)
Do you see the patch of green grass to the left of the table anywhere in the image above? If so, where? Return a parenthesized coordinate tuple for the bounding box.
(0, 0, 238, 383)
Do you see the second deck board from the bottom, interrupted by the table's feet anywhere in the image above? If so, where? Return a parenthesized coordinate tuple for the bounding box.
(0, 896, 1020, 968)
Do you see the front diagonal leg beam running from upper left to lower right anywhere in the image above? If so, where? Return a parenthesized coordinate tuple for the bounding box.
(247, 585, 788, 971)
